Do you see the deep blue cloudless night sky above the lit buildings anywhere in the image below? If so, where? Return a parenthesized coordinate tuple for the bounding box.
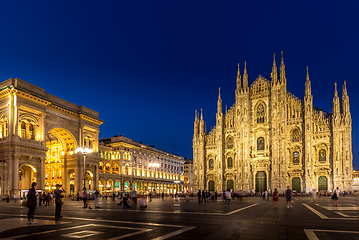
(0, 1, 359, 168)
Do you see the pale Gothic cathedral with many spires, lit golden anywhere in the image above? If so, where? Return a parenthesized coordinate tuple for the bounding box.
(193, 54, 353, 192)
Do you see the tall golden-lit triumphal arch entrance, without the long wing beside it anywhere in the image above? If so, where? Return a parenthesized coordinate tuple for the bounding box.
(0, 79, 103, 197)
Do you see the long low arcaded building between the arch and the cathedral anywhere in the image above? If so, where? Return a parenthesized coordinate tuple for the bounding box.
(99, 136, 185, 194)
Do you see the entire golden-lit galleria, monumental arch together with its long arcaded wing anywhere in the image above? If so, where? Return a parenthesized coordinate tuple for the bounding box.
(0, 79, 185, 197)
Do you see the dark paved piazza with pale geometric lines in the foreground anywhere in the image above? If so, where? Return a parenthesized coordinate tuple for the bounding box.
(0, 196, 359, 240)
